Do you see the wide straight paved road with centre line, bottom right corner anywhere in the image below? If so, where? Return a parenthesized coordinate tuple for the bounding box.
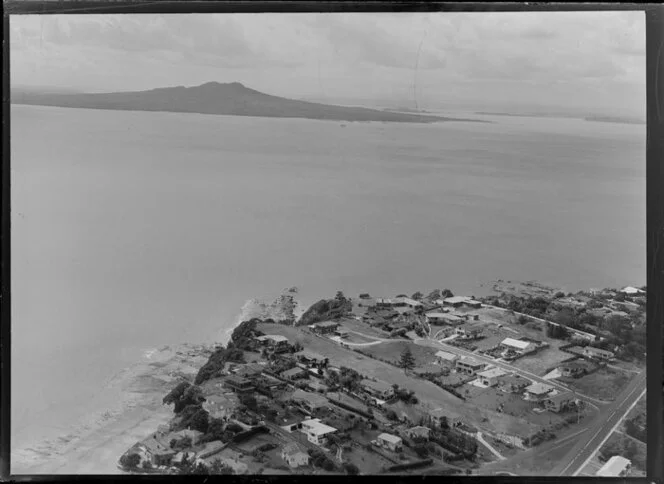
(549, 371, 646, 476)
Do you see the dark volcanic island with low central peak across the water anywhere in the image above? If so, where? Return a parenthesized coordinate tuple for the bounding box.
(11, 82, 482, 123)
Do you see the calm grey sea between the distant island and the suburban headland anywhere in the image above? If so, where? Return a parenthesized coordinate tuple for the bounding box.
(11, 106, 646, 462)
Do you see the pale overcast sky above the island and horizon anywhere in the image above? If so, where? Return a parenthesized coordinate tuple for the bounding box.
(10, 12, 645, 114)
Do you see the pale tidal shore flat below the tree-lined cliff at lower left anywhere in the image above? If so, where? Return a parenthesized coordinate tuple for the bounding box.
(11, 344, 210, 474)
